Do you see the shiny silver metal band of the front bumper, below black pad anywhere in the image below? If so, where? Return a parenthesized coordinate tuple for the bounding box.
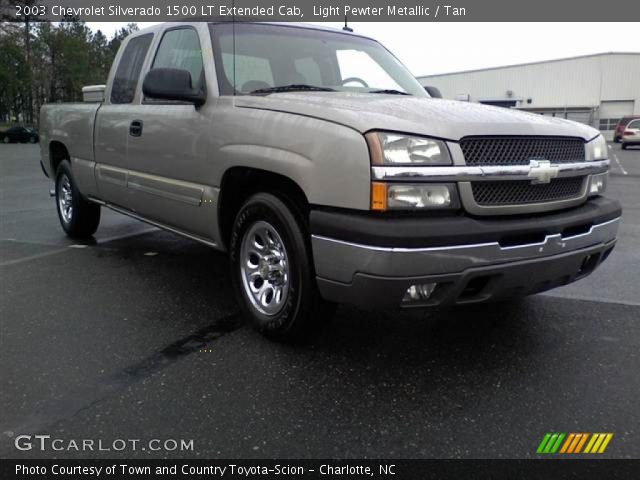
(312, 217, 620, 283)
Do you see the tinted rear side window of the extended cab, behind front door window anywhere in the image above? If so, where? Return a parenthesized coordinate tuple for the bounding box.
(111, 33, 153, 103)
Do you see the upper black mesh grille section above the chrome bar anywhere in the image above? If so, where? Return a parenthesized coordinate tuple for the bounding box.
(460, 137, 585, 165)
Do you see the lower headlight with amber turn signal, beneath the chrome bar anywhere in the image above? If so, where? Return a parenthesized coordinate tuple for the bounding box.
(371, 182, 460, 211)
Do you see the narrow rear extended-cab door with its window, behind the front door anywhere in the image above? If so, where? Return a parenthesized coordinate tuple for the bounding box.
(94, 33, 153, 208)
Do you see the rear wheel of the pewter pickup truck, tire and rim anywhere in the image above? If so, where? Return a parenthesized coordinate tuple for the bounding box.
(56, 160, 100, 238)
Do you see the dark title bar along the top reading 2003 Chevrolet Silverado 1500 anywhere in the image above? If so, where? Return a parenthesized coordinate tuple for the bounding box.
(0, 0, 640, 22)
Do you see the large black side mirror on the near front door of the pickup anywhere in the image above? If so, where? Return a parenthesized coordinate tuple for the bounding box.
(142, 68, 206, 106)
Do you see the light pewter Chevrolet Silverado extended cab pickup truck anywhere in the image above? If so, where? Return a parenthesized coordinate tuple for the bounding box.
(40, 22, 621, 340)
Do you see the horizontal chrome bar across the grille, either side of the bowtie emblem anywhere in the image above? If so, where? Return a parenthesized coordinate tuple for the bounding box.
(371, 160, 610, 182)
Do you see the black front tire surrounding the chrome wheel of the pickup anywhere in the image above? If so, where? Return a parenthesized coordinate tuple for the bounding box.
(230, 193, 335, 343)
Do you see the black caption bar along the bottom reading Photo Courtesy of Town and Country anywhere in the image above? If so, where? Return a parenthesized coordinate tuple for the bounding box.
(0, 459, 640, 480)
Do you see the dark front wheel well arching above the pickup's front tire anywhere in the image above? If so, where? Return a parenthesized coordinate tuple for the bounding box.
(218, 167, 309, 247)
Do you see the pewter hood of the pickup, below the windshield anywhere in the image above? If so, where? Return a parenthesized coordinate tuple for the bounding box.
(235, 92, 599, 141)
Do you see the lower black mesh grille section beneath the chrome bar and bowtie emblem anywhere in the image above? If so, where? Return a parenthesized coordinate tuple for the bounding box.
(471, 177, 585, 206)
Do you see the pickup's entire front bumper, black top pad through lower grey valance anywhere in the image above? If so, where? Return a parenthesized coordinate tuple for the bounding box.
(311, 198, 621, 308)
